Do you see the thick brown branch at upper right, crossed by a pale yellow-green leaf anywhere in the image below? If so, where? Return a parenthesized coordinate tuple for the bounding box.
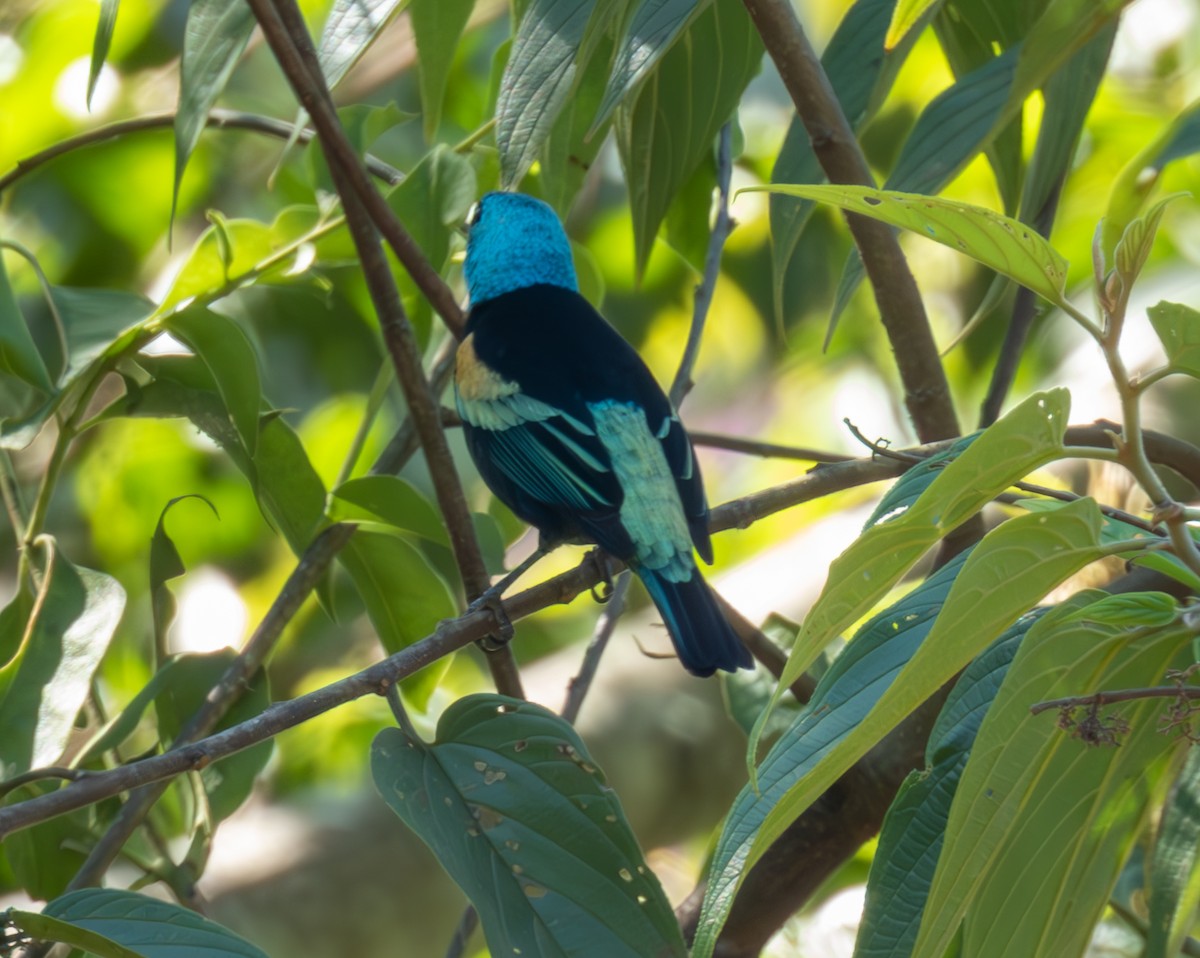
(743, 0, 959, 442)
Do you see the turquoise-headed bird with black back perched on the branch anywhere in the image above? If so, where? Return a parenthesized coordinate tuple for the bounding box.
(455, 192, 754, 677)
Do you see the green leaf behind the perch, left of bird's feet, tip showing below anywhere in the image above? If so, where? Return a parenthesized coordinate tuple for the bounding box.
(337, 528, 457, 708)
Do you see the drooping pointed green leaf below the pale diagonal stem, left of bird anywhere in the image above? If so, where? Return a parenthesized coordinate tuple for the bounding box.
(166, 307, 263, 456)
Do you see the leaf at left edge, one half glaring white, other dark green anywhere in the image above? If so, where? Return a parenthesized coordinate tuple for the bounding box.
(0, 543, 125, 778)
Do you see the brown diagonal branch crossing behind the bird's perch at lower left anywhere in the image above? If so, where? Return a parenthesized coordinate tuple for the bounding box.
(67, 522, 355, 891)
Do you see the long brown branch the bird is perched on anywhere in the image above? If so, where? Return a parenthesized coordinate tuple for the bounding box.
(0, 451, 926, 839)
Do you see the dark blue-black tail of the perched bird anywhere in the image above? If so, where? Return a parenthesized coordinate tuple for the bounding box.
(636, 568, 754, 676)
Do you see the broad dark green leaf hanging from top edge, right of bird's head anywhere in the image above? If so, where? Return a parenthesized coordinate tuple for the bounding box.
(614, 0, 762, 274)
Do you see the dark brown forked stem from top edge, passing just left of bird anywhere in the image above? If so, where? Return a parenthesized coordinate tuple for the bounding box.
(250, 0, 523, 697)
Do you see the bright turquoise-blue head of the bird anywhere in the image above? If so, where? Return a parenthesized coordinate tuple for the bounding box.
(463, 193, 580, 304)
